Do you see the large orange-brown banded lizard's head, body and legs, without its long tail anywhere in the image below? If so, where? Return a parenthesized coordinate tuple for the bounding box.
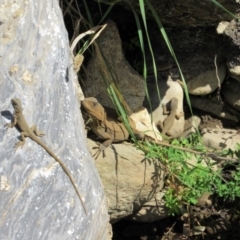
(82, 97, 144, 157)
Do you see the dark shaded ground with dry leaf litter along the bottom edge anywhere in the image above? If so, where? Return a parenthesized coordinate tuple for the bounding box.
(113, 199, 240, 240)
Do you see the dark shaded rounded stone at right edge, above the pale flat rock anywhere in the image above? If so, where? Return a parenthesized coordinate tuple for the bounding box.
(222, 78, 240, 111)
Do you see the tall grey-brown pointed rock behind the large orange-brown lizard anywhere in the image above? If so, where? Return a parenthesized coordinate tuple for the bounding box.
(83, 21, 145, 112)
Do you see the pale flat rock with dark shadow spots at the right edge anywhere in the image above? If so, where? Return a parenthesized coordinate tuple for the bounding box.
(201, 128, 240, 150)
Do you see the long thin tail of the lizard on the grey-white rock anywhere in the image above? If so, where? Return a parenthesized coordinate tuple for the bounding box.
(30, 136, 87, 214)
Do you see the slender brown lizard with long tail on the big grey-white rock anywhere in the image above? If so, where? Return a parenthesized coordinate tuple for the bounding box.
(5, 98, 87, 214)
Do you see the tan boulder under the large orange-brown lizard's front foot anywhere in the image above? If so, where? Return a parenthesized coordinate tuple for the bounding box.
(88, 139, 165, 223)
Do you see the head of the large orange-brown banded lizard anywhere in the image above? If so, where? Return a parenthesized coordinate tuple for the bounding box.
(82, 97, 106, 121)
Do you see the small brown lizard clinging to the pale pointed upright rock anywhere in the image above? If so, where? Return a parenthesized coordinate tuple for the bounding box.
(156, 97, 183, 135)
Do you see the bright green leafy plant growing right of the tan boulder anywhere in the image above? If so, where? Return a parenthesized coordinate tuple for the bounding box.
(139, 138, 240, 215)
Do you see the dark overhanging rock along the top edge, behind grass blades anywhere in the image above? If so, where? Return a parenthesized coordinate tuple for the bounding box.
(111, 0, 239, 27)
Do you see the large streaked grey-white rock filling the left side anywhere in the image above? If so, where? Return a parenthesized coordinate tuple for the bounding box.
(0, 0, 109, 240)
